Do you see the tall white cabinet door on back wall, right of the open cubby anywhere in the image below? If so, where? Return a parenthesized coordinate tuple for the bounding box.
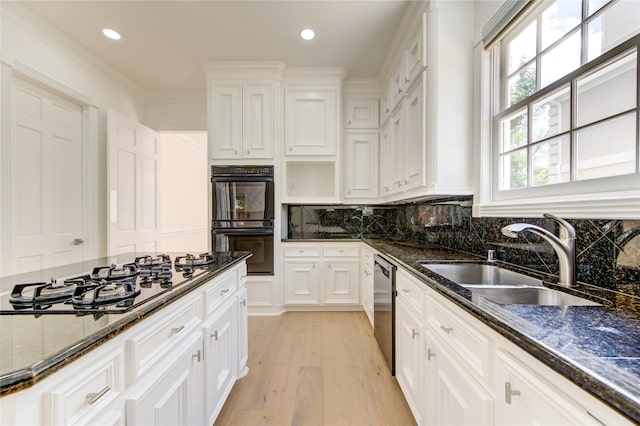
(343, 132, 378, 200)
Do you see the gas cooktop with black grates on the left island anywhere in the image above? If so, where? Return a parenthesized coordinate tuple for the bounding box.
(0, 253, 234, 315)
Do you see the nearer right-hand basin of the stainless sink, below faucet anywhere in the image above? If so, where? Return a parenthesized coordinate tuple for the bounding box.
(467, 287, 602, 306)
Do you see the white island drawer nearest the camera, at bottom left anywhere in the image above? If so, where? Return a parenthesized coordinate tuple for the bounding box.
(43, 349, 123, 425)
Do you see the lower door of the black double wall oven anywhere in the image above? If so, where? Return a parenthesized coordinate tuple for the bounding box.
(213, 233, 273, 275)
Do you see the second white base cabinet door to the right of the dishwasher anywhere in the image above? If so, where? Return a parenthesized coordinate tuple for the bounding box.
(424, 331, 494, 426)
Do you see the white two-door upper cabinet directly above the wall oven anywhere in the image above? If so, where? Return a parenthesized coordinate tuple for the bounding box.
(209, 83, 274, 160)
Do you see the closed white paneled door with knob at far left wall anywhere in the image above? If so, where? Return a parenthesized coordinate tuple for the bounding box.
(8, 77, 83, 274)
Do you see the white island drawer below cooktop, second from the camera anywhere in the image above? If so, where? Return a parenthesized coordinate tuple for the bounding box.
(125, 292, 202, 385)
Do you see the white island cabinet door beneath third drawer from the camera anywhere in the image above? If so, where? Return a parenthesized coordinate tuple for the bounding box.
(202, 298, 238, 424)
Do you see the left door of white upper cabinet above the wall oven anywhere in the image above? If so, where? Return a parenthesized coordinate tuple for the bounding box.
(209, 84, 242, 159)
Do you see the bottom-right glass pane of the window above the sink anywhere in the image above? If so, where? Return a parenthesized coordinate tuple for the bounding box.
(576, 112, 637, 180)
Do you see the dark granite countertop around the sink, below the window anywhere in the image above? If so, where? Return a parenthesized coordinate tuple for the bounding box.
(360, 238, 640, 422)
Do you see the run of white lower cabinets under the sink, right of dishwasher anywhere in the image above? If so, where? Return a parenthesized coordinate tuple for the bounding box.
(396, 262, 632, 426)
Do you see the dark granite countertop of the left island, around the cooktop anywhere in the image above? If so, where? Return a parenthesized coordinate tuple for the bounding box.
(0, 252, 251, 396)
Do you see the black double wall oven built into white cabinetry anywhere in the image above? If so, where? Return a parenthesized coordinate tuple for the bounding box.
(211, 166, 274, 275)
